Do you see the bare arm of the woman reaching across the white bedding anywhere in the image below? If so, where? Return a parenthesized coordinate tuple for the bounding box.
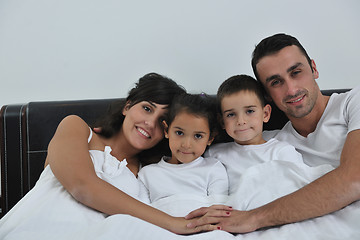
(47, 116, 216, 234)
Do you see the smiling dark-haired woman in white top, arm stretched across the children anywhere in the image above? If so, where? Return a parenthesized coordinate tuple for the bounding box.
(0, 73, 221, 239)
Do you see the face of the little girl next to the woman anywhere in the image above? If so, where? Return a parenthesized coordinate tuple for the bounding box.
(165, 112, 213, 164)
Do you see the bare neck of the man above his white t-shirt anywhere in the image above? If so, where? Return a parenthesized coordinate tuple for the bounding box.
(288, 95, 330, 137)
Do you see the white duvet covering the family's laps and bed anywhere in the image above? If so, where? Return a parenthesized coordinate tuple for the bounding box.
(0, 158, 360, 240)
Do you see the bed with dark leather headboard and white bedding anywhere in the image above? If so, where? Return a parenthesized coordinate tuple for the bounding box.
(0, 89, 360, 239)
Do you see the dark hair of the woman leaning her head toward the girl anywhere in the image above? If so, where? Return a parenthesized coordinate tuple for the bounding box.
(95, 73, 186, 165)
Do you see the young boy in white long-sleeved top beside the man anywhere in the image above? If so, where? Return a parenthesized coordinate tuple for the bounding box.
(205, 75, 303, 195)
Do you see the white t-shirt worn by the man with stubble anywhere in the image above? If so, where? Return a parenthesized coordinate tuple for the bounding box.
(263, 86, 360, 167)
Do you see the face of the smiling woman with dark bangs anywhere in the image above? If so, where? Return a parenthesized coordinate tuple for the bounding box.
(122, 101, 168, 150)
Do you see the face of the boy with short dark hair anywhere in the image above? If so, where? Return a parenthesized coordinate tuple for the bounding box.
(221, 91, 271, 145)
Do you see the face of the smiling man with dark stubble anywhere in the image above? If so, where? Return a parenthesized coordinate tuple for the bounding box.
(256, 45, 320, 118)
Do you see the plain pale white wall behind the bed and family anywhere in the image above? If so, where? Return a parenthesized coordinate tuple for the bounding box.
(0, 0, 360, 105)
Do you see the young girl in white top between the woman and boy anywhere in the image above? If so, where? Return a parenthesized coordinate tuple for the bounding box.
(139, 94, 228, 216)
